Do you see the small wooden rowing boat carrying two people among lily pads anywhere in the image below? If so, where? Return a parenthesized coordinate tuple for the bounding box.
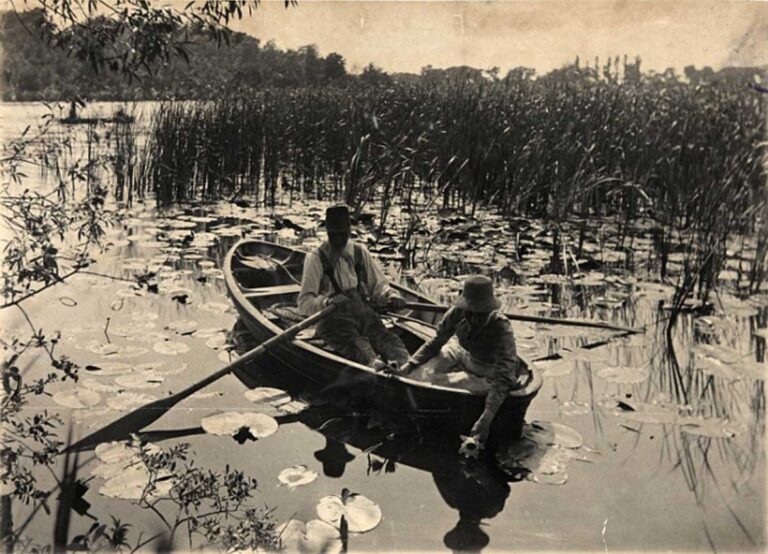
(224, 239, 542, 443)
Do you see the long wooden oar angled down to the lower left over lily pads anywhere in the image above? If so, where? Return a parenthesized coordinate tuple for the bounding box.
(66, 305, 336, 452)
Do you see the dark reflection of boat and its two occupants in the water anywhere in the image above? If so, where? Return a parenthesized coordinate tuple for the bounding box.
(232, 344, 518, 552)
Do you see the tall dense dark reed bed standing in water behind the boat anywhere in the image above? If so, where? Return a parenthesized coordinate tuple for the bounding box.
(143, 71, 766, 302)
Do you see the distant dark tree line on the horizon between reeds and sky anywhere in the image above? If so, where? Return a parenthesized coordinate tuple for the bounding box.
(0, 9, 765, 101)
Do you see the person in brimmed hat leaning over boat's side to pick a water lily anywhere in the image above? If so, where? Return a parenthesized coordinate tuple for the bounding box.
(396, 275, 531, 456)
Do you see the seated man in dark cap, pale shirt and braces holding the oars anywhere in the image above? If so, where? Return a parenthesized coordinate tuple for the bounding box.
(298, 204, 408, 371)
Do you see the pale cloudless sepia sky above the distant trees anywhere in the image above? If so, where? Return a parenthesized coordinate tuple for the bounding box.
(230, 0, 768, 74)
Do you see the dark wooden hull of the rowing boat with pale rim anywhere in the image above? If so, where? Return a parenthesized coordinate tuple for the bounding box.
(224, 240, 541, 440)
